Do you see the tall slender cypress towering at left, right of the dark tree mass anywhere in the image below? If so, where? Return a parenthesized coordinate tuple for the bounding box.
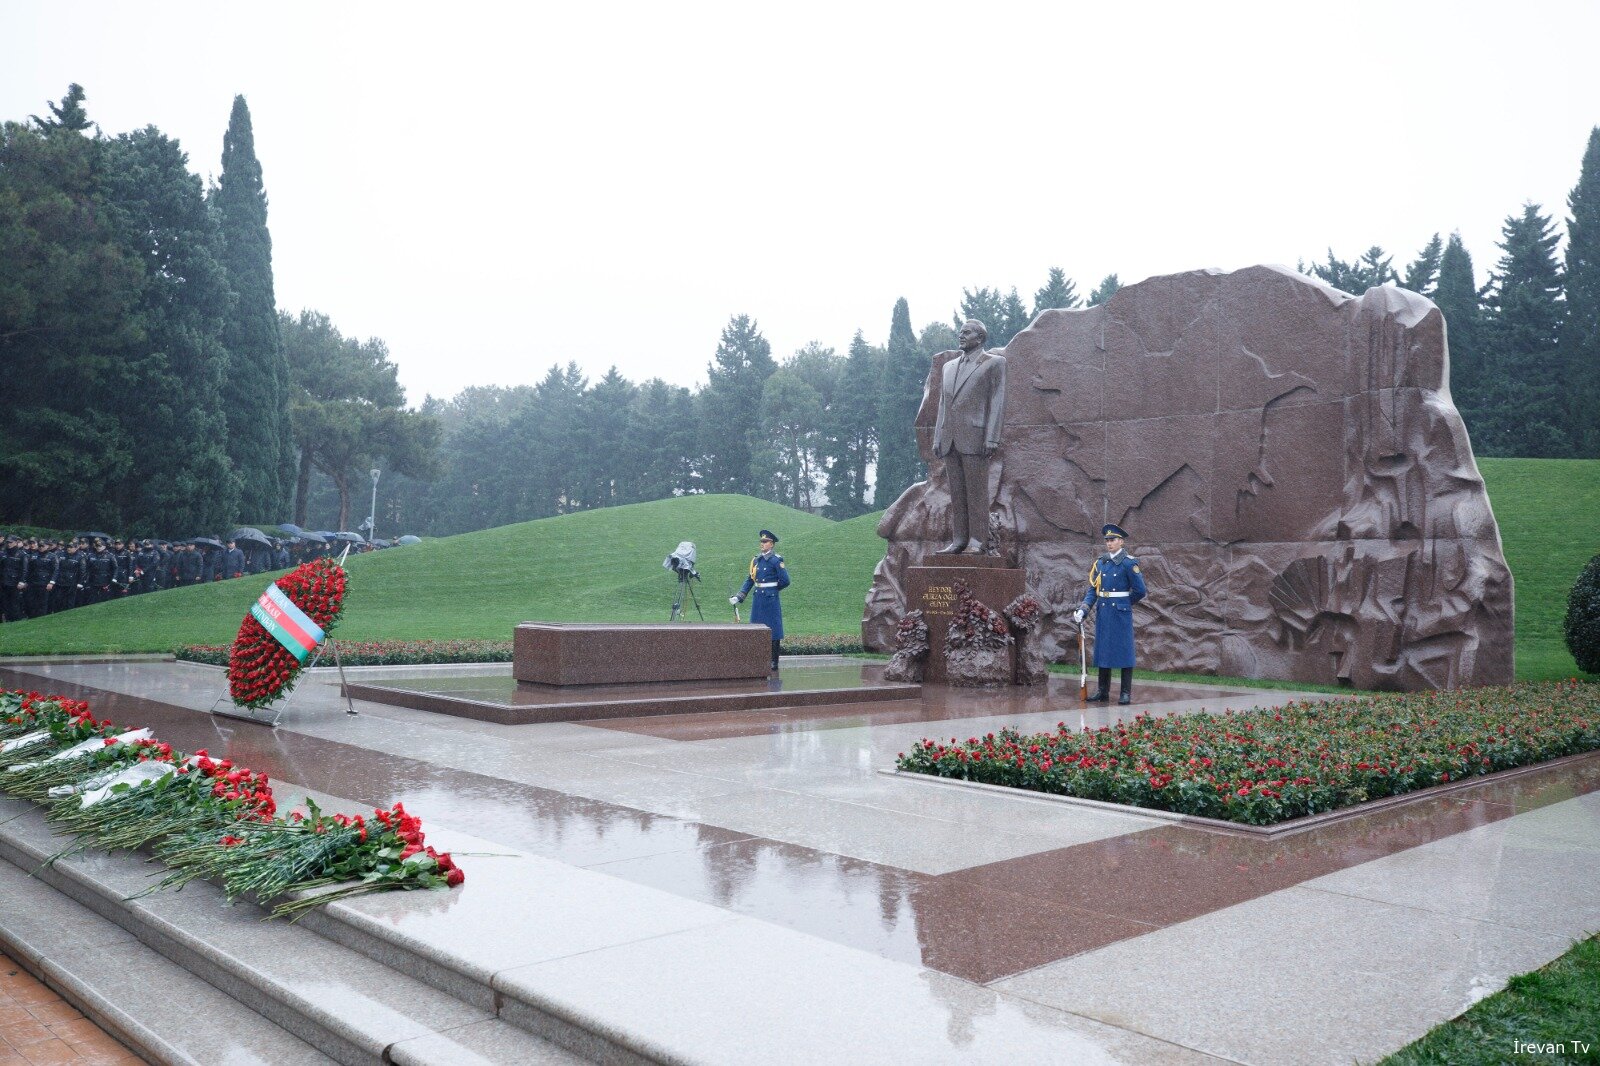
(214, 96, 294, 520)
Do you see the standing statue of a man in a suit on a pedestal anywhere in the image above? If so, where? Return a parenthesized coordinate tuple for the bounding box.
(933, 319, 1005, 554)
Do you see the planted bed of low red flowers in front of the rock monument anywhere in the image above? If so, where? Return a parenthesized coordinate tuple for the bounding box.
(896, 682, 1600, 826)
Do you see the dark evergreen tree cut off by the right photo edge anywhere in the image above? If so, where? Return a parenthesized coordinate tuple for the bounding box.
(1562, 126, 1600, 459)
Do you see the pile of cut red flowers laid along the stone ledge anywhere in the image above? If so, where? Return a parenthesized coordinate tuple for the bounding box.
(0, 691, 466, 917)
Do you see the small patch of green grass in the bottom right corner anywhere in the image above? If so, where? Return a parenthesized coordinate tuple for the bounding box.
(1379, 938, 1600, 1066)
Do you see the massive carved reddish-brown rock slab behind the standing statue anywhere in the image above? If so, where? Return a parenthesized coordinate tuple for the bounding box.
(862, 266, 1512, 690)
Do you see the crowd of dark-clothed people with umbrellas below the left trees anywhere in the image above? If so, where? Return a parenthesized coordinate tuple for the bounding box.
(0, 535, 370, 623)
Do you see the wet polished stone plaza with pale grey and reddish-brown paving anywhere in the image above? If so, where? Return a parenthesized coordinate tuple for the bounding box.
(0, 658, 1600, 1063)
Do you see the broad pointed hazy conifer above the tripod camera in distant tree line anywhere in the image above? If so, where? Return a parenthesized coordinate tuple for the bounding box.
(699, 315, 778, 496)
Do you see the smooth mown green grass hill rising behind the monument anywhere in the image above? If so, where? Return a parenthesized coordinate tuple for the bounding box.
(0, 459, 1600, 679)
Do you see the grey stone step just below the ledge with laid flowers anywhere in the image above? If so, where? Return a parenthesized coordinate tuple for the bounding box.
(0, 797, 586, 1066)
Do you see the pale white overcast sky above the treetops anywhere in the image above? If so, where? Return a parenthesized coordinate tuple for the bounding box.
(0, 0, 1600, 402)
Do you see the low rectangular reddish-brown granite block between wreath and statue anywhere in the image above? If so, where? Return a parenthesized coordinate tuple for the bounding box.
(512, 623, 773, 685)
